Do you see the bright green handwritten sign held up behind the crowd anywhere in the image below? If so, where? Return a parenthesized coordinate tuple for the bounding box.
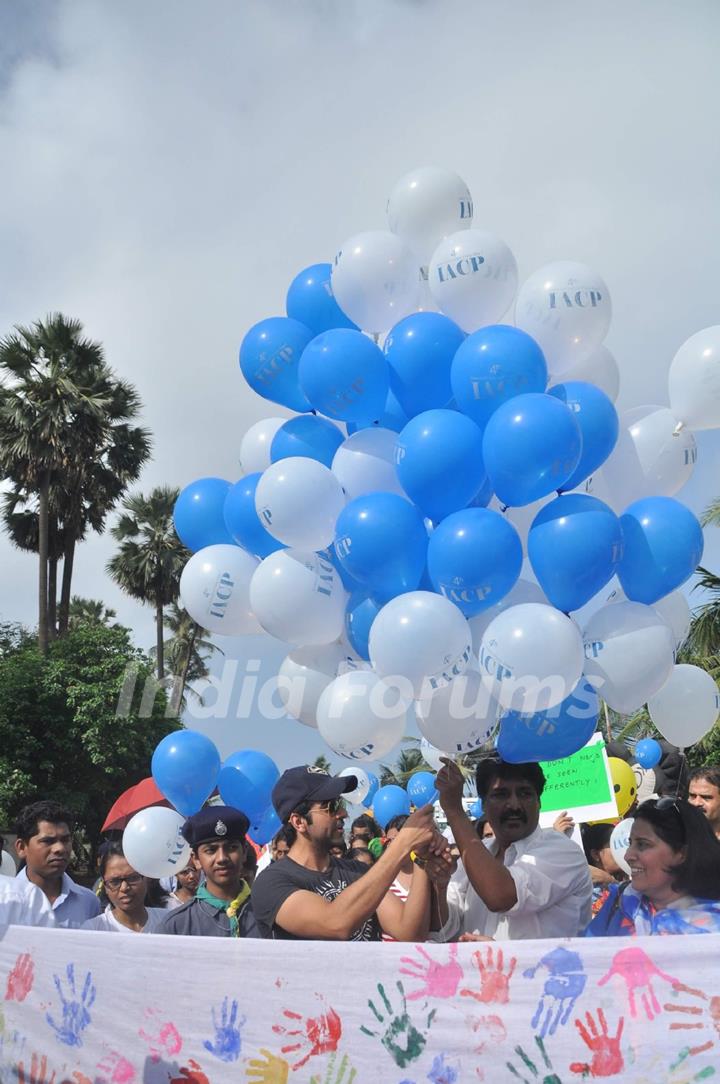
(540, 735, 617, 820)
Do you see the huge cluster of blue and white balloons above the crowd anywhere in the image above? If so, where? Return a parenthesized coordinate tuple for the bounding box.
(176, 162, 720, 771)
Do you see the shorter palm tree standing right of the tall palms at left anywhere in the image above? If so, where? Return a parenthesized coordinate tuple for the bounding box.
(106, 486, 190, 681)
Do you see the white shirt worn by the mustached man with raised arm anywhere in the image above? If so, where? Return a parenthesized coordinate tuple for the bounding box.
(434, 828, 592, 941)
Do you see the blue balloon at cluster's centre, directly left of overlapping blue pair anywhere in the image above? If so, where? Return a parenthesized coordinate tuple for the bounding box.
(396, 410, 487, 522)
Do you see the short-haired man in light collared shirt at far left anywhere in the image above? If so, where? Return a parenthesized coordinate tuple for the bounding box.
(15, 801, 102, 928)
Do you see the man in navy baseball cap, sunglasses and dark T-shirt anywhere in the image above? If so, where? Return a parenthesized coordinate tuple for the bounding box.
(253, 766, 447, 941)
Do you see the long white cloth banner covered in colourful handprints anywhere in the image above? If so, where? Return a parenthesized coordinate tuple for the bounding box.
(0, 927, 720, 1084)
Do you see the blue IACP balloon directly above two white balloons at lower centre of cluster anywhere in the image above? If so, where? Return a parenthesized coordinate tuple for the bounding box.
(427, 508, 523, 617)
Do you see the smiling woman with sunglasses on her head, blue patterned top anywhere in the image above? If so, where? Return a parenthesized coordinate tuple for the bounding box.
(586, 798, 720, 938)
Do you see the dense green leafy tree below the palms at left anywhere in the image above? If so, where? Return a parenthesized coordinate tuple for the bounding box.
(0, 623, 177, 839)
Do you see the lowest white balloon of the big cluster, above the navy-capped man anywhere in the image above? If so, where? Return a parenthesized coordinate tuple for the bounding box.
(318, 670, 409, 761)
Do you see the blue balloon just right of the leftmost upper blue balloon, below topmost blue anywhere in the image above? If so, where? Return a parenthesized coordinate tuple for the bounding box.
(299, 327, 389, 422)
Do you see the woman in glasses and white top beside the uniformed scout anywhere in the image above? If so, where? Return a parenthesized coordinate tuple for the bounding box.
(81, 843, 167, 933)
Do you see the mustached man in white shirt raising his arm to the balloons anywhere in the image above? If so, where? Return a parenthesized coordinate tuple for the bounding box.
(434, 758, 592, 941)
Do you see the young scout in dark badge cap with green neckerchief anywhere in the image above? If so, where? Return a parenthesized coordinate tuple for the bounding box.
(155, 805, 260, 938)
